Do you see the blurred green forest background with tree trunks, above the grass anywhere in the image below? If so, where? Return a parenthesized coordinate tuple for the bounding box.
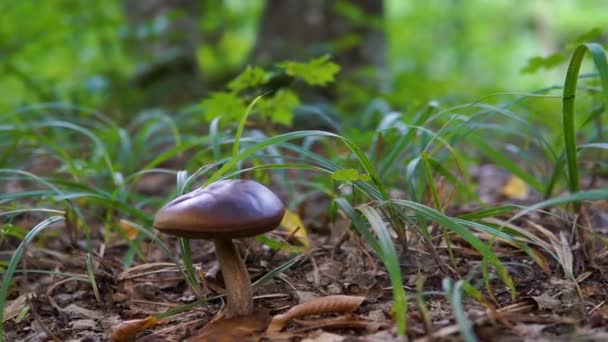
(0, 0, 608, 120)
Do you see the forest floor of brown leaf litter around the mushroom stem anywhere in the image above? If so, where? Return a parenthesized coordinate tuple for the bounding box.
(4, 167, 608, 342)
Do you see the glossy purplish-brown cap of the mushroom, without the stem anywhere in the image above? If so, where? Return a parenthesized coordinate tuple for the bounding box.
(154, 179, 285, 239)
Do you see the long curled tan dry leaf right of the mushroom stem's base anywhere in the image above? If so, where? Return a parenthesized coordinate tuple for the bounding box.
(266, 295, 365, 335)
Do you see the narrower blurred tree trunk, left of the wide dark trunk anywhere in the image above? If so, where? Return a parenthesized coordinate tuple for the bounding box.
(125, 0, 204, 109)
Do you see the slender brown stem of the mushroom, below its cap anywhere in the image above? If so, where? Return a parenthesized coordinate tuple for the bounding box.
(213, 239, 253, 318)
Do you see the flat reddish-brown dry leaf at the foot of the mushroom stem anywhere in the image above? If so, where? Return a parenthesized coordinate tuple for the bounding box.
(188, 311, 269, 342)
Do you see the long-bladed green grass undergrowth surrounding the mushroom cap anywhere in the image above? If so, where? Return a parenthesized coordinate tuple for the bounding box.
(0, 44, 608, 340)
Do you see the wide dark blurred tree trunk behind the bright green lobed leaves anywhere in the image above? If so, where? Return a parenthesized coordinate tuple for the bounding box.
(251, 0, 386, 99)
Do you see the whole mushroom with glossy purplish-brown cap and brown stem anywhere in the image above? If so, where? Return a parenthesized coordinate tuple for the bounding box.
(154, 179, 285, 317)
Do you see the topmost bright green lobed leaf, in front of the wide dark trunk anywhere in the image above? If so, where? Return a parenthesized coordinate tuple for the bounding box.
(279, 56, 340, 86)
